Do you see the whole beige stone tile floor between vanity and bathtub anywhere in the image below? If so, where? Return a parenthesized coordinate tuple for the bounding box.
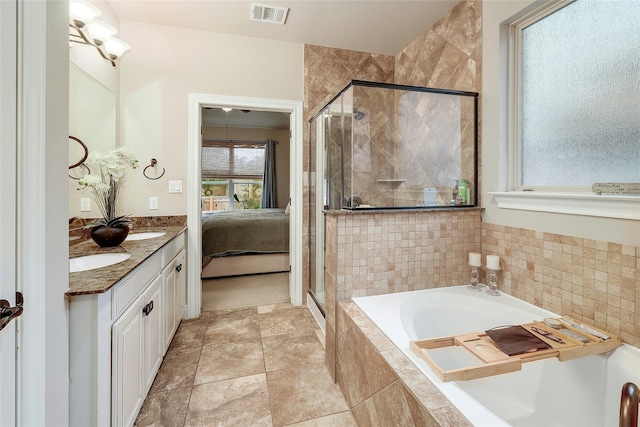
(135, 303, 357, 427)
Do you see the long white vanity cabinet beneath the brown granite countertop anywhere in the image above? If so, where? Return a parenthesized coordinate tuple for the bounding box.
(69, 232, 186, 426)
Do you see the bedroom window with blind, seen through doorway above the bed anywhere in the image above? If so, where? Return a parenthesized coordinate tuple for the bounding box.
(202, 142, 265, 212)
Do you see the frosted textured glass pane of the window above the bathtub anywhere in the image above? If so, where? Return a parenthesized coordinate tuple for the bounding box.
(520, 0, 640, 187)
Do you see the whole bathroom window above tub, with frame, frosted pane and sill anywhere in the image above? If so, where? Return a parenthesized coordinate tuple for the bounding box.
(496, 0, 640, 221)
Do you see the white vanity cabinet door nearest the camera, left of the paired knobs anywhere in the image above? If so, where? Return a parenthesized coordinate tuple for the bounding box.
(112, 298, 145, 426)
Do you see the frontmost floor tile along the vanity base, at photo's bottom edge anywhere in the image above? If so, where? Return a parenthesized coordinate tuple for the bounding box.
(135, 386, 191, 427)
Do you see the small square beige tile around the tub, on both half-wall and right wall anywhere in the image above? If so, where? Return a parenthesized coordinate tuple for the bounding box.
(326, 209, 640, 347)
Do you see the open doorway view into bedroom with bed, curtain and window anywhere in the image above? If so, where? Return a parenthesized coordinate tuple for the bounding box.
(200, 106, 291, 311)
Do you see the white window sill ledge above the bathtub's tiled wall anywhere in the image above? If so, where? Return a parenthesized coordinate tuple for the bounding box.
(489, 191, 640, 221)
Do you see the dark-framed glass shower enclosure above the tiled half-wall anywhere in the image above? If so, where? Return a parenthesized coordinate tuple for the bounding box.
(308, 80, 478, 309)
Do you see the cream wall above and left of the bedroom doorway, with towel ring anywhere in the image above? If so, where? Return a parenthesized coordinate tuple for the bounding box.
(119, 21, 304, 216)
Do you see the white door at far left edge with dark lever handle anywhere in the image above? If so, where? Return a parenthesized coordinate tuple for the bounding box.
(0, 1, 17, 426)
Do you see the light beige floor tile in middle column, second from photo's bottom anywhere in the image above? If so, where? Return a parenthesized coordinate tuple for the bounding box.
(194, 340, 265, 384)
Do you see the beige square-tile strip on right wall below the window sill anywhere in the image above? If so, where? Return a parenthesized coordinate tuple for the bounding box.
(482, 223, 640, 347)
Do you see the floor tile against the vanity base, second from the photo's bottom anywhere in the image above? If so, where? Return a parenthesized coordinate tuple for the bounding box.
(150, 347, 201, 393)
